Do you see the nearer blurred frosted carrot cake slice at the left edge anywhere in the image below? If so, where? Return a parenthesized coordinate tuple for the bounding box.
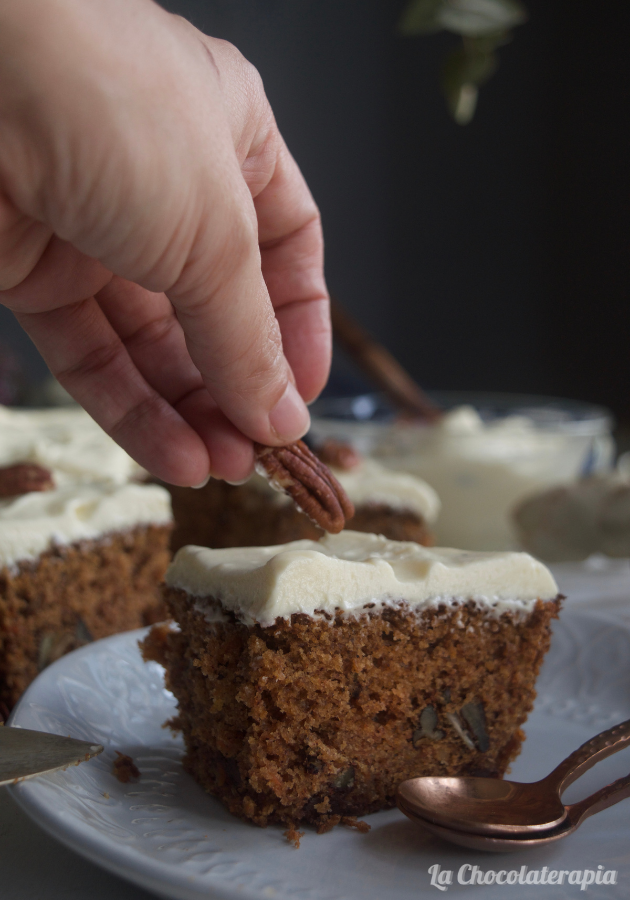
(0, 478, 171, 714)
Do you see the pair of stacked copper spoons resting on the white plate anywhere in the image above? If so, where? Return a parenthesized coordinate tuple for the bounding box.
(397, 720, 630, 849)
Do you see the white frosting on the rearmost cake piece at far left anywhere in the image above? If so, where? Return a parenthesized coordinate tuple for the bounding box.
(0, 406, 146, 487)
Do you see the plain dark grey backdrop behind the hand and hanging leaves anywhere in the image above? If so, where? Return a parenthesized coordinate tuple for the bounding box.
(0, 0, 630, 421)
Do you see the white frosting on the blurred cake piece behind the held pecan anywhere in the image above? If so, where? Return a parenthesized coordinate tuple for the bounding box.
(248, 459, 440, 525)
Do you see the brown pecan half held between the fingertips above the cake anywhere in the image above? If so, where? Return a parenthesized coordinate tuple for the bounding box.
(254, 441, 354, 534)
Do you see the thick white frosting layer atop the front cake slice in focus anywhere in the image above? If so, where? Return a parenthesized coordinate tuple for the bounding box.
(166, 531, 558, 625)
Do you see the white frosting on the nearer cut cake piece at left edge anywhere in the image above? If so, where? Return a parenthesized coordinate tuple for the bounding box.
(0, 484, 171, 568)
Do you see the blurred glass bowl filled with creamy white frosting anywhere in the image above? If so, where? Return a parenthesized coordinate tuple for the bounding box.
(311, 391, 615, 550)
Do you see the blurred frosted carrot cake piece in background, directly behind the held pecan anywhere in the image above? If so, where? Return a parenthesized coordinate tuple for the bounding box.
(165, 441, 440, 551)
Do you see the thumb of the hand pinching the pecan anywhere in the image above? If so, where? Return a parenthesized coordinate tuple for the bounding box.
(167, 198, 310, 446)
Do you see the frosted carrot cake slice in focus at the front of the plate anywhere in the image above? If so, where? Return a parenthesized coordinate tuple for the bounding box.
(144, 531, 560, 830)
